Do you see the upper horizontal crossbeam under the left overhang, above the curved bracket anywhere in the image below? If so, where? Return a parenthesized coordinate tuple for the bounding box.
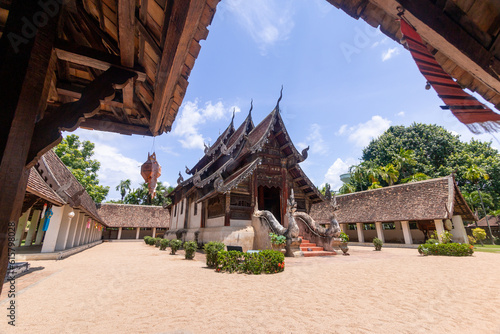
(55, 40, 146, 81)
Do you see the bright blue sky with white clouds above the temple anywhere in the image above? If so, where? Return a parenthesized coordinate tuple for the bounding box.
(70, 0, 500, 200)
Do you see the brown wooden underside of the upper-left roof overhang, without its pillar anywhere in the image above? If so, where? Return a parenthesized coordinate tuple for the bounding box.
(0, 0, 220, 140)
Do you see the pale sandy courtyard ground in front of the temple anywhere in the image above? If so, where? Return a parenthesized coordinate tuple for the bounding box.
(0, 242, 500, 334)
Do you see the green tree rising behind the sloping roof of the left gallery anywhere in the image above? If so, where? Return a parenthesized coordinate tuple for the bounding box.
(54, 135, 109, 203)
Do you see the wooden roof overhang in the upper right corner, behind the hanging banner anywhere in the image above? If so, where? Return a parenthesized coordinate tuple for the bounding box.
(327, 0, 500, 114)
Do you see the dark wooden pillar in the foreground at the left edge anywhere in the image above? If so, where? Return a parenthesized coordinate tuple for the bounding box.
(0, 1, 61, 292)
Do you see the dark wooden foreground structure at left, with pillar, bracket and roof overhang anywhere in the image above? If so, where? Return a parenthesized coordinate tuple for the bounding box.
(0, 0, 219, 288)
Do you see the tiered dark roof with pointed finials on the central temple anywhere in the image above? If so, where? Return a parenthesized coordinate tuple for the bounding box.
(170, 97, 323, 204)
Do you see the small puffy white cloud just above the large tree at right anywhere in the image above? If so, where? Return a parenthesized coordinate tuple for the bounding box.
(337, 115, 391, 147)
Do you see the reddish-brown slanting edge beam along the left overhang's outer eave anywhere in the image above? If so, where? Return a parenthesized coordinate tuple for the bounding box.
(150, 0, 206, 135)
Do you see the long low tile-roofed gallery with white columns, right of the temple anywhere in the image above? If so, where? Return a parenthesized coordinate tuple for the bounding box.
(310, 175, 477, 244)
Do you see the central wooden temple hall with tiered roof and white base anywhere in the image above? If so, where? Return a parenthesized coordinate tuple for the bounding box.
(167, 97, 324, 250)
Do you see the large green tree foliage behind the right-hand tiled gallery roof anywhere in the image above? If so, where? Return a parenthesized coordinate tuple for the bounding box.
(342, 123, 500, 217)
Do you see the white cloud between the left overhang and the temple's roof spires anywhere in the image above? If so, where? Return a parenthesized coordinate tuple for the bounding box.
(172, 100, 241, 149)
